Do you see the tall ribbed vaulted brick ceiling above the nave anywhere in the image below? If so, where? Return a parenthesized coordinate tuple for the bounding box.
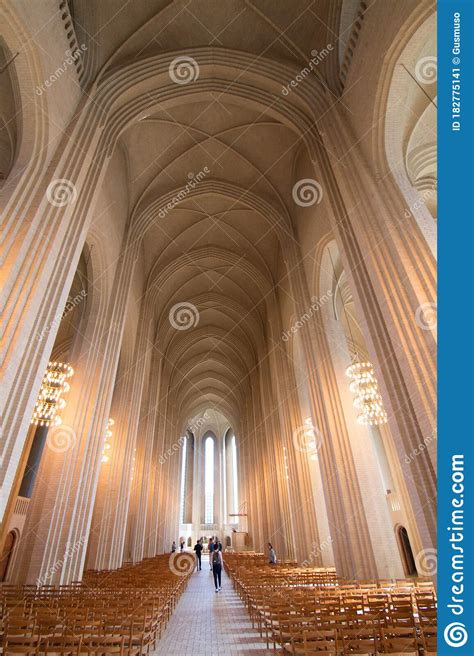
(70, 0, 352, 436)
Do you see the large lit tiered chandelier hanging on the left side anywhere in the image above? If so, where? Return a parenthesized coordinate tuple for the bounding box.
(31, 362, 74, 426)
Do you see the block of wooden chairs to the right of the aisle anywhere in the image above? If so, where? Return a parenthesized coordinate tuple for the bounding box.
(225, 554, 437, 656)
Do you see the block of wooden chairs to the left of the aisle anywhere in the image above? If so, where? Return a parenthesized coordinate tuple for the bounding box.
(0, 555, 192, 656)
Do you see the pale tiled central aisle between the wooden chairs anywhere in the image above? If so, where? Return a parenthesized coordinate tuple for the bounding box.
(154, 556, 271, 656)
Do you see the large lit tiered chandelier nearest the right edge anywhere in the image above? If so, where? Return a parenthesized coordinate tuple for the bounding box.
(346, 362, 388, 426)
